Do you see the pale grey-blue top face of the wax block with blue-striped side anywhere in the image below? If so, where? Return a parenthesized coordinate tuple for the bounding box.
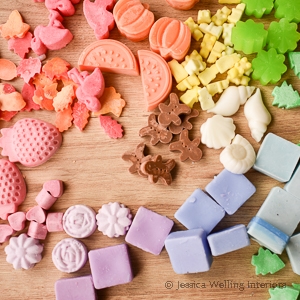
(256, 187, 300, 236)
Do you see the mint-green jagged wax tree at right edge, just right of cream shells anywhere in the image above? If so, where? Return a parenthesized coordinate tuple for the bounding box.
(272, 81, 300, 109)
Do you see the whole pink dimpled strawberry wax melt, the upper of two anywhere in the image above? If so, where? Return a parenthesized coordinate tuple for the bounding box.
(0, 118, 62, 167)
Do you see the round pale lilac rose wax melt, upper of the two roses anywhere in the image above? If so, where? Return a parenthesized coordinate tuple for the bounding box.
(63, 205, 97, 238)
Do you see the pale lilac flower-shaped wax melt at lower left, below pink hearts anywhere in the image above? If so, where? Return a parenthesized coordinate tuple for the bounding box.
(4, 233, 43, 270)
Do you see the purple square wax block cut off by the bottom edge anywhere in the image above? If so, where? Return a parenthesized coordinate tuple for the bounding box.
(55, 275, 97, 300)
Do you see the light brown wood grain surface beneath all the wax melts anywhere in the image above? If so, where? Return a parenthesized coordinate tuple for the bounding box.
(0, 0, 300, 300)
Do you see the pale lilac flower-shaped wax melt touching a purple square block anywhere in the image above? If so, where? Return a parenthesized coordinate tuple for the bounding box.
(96, 202, 132, 237)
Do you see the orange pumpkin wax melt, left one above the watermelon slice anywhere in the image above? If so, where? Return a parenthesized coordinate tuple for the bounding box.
(113, 0, 154, 42)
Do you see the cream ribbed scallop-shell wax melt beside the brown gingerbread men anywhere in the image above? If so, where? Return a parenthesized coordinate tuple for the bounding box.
(200, 115, 235, 149)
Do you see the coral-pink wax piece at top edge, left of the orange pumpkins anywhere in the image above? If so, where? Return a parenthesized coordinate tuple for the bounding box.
(83, 0, 115, 40)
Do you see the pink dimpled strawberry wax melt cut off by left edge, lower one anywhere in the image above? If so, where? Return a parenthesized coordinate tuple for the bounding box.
(0, 159, 26, 220)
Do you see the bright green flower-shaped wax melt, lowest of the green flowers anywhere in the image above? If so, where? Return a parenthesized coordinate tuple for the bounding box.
(252, 48, 287, 85)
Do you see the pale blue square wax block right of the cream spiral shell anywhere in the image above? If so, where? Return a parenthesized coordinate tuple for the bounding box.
(253, 133, 300, 182)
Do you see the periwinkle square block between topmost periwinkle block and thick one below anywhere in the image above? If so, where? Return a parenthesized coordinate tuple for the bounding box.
(174, 189, 225, 234)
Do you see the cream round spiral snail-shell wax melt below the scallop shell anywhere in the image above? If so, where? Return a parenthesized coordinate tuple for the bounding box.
(220, 134, 256, 174)
